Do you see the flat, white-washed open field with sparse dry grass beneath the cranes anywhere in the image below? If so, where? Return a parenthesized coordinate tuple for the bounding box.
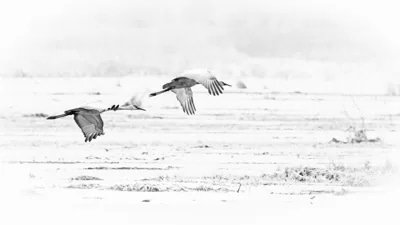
(0, 78, 400, 224)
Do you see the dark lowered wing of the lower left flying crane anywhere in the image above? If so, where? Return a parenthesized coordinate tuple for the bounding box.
(74, 114, 104, 142)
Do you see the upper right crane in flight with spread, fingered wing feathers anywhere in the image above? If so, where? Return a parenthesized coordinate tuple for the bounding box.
(149, 71, 231, 115)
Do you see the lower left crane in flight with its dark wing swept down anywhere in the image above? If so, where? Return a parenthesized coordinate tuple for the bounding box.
(47, 104, 145, 142)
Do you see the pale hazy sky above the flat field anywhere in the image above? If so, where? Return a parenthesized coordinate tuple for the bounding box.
(0, 0, 400, 77)
